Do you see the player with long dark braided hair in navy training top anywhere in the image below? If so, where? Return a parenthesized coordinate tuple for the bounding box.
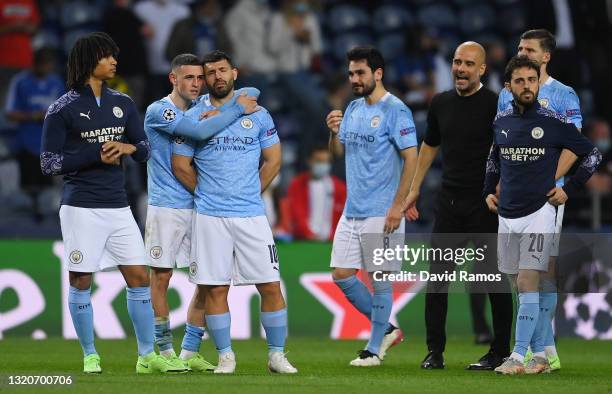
(40, 33, 182, 373)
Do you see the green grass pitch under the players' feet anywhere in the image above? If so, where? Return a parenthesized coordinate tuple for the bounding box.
(0, 337, 612, 394)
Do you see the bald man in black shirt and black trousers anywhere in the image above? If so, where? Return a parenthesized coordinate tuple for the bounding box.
(406, 41, 512, 370)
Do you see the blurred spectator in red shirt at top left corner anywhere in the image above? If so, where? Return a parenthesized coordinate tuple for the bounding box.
(0, 0, 40, 129)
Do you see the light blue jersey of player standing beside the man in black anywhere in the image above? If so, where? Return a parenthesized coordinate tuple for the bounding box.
(338, 93, 417, 219)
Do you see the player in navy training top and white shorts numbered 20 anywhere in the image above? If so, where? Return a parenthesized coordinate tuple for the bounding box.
(484, 56, 601, 375)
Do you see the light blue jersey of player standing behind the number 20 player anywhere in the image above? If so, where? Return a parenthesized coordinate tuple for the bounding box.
(497, 76, 582, 187)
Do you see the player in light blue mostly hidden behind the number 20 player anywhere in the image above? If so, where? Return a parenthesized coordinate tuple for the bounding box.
(497, 29, 582, 371)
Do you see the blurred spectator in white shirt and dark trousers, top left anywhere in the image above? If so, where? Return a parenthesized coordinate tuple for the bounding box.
(134, 0, 189, 102)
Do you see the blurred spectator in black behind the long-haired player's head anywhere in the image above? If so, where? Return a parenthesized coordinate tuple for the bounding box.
(102, 0, 153, 110)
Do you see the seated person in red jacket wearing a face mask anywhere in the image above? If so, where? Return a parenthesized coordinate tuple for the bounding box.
(285, 146, 346, 241)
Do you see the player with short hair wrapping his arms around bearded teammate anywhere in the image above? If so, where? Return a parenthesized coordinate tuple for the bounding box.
(145, 54, 257, 371)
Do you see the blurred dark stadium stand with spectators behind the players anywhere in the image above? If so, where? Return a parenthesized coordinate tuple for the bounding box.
(0, 0, 612, 239)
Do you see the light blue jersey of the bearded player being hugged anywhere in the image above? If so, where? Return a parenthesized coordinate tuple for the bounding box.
(174, 95, 280, 217)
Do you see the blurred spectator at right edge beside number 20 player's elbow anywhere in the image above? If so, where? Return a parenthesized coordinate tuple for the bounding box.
(584, 119, 612, 195)
